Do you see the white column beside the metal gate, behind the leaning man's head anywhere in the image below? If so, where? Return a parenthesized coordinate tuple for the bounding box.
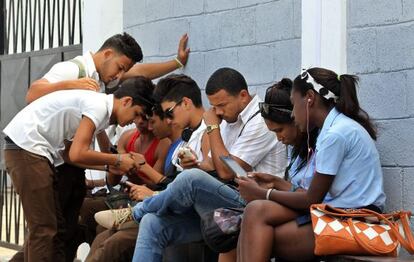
(82, 0, 123, 52)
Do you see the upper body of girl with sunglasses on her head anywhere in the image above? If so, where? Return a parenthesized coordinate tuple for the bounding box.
(251, 78, 318, 191)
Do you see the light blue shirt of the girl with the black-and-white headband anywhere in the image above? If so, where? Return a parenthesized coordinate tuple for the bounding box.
(315, 108, 386, 210)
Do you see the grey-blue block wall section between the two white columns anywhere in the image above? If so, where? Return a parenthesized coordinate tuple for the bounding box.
(124, 0, 301, 97)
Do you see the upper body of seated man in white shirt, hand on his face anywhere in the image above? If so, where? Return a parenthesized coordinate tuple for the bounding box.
(204, 68, 287, 180)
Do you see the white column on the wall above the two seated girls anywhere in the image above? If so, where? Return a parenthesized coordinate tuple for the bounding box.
(302, 0, 347, 74)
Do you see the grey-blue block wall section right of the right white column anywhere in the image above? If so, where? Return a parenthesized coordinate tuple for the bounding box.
(347, 0, 414, 210)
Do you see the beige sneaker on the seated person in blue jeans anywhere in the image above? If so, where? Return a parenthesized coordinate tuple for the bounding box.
(95, 207, 138, 230)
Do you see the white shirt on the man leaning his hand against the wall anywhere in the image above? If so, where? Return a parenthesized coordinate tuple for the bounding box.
(43, 52, 105, 92)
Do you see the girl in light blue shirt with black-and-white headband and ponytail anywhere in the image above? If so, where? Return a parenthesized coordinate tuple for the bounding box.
(238, 68, 385, 262)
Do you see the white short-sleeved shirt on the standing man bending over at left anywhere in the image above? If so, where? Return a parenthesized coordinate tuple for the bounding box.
(3, 90, 114, 165)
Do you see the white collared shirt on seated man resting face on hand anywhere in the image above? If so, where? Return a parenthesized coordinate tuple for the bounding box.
(220, 95, 288, 177)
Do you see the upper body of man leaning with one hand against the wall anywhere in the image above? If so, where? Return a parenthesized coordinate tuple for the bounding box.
(26, 33, 190, 103)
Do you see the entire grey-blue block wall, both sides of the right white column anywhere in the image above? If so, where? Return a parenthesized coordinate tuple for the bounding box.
(124, 0, 414, 213)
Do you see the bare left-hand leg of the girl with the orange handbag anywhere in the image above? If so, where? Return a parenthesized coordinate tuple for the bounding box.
(238, 200, 298, 262)
